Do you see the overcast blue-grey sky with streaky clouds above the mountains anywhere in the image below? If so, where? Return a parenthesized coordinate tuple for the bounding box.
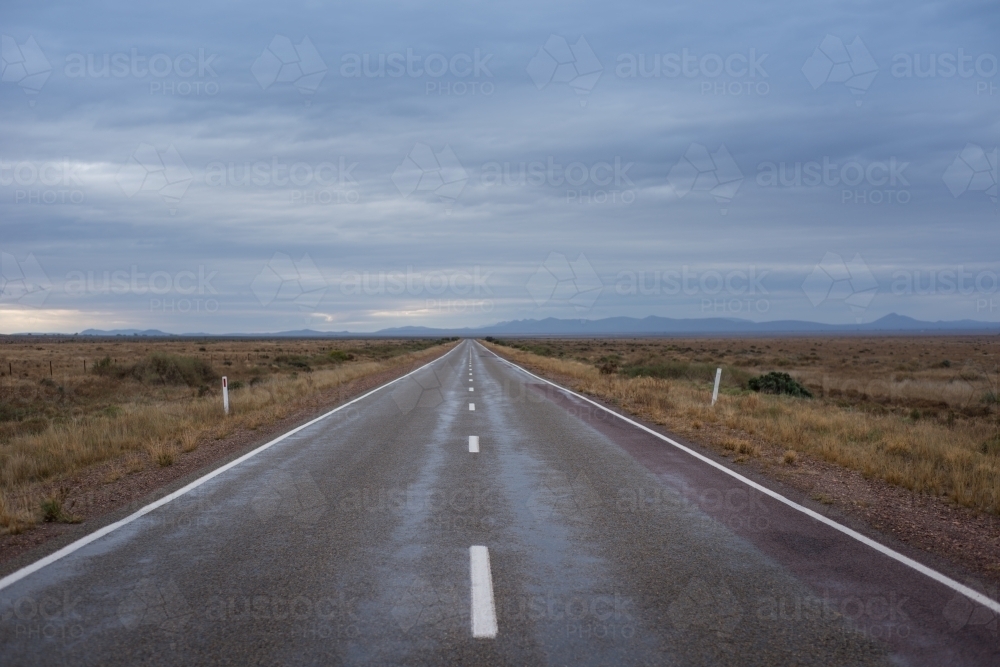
(0, 0, 1000, 333)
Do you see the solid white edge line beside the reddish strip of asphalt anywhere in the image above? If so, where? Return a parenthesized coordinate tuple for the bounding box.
(474, 350, 1000, 614)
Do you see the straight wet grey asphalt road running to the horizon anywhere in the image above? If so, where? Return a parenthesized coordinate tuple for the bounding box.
(0, 341, 1000, 665)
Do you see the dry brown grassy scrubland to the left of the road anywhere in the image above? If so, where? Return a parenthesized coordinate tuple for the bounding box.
(0, 336, 450, 533)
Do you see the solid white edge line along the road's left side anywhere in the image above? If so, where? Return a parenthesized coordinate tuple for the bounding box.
(0, 345, 466, 591)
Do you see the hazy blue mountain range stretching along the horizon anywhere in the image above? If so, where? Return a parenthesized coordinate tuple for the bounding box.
(56, 313, 1000, 338)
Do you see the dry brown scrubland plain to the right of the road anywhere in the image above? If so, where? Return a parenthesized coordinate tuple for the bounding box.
(487, 336, 1000, 514)
